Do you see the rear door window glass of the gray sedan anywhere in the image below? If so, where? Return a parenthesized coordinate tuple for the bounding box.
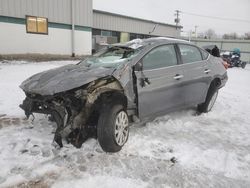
(179, 44, 203, 64)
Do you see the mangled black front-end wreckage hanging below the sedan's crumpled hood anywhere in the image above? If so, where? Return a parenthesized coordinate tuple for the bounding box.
(19, 94, 88, 147)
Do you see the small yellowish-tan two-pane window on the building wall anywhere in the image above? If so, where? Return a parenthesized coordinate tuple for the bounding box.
(26, 16, 48, 34)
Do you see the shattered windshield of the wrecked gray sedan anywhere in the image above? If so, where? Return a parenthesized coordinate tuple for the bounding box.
(80, 46, 140, 68)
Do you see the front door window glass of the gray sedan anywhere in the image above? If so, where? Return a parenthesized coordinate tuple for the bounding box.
(143, 45, 177, 70)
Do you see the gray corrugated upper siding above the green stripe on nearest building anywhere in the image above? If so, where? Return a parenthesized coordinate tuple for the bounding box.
(0, 0, 93, 27)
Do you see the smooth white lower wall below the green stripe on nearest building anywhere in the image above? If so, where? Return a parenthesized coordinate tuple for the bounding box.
(0, 22, 92, 55)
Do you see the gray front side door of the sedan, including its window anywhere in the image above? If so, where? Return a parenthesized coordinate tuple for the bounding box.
(136, 45, 185, 119)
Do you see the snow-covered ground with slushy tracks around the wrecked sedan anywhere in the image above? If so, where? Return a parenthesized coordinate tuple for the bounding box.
(0, 62, 250, 188)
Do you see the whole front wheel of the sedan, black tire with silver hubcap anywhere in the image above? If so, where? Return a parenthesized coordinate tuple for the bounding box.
(97, 104, 129, 152)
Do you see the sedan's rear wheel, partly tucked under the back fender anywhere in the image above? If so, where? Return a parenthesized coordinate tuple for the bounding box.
(197, 82, 219, 113)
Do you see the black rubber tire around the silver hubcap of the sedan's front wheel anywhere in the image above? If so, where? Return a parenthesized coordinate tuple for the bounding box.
(97, 104, 129, 152)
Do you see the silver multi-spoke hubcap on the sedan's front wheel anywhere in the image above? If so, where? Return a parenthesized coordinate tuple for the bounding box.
(115, 111, 129, 146)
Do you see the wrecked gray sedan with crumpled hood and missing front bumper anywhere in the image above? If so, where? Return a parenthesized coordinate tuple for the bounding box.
(20, 38, 227, 152)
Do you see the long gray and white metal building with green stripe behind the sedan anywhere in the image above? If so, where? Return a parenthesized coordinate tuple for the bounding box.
(0, 0, 181, 55)
